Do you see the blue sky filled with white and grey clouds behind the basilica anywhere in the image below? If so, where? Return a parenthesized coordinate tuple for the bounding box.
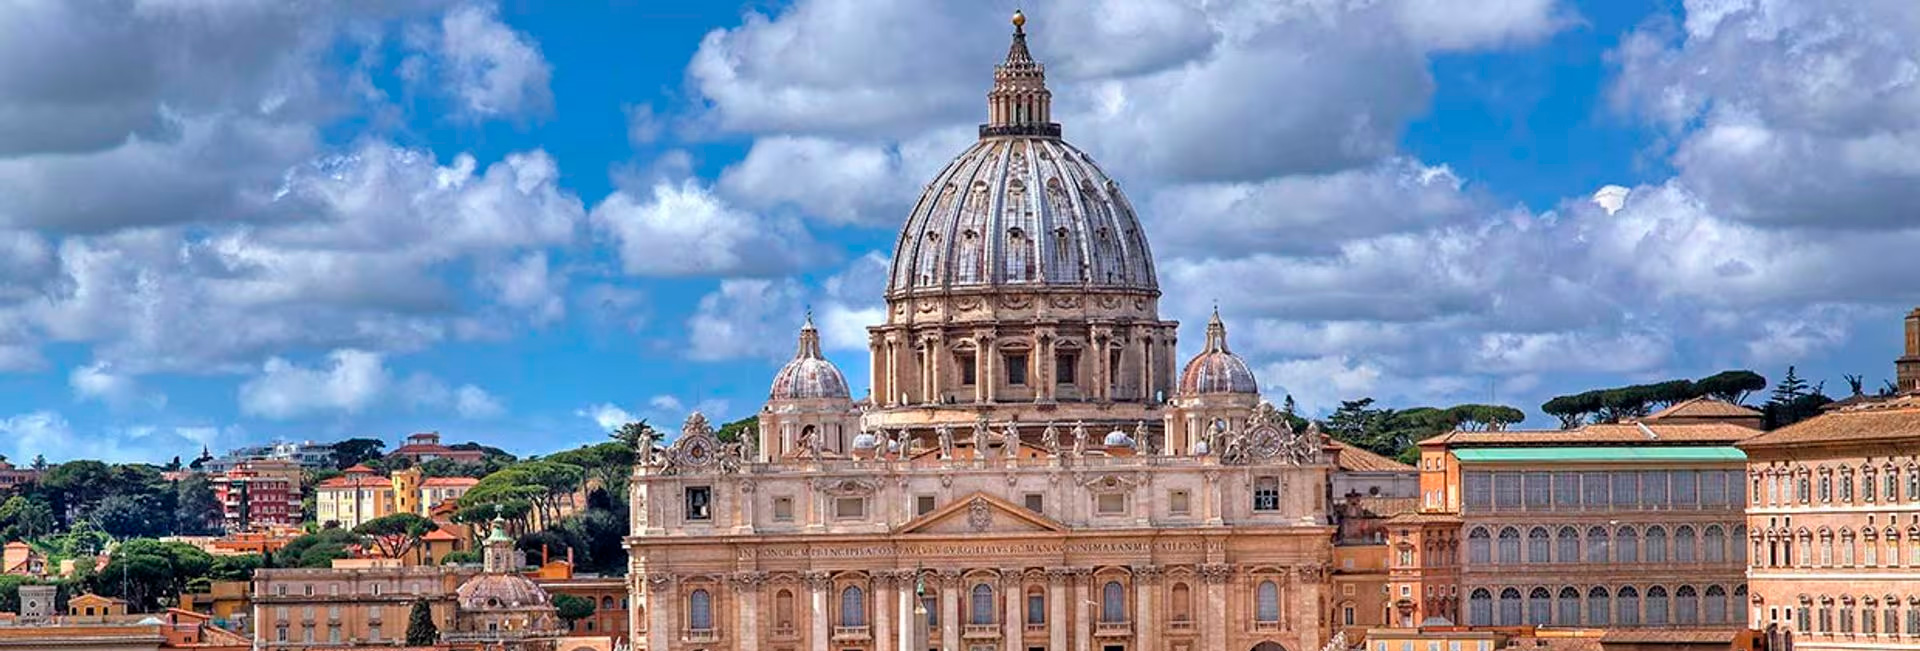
(0, 0, 1920, 463)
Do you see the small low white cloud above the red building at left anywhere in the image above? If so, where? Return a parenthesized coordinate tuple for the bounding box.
(240, 350, 394, 421)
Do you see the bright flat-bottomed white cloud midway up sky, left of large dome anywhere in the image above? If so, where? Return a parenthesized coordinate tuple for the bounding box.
(591, 179, 818, 277)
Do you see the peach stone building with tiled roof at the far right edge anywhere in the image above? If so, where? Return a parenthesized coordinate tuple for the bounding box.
(1741, 394, 1920, 649)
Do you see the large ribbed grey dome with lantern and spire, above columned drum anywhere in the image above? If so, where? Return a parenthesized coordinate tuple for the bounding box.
(887, 13, 1160, 298)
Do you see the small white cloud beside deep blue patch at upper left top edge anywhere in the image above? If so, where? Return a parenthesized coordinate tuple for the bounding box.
(410, 4, 553, 117)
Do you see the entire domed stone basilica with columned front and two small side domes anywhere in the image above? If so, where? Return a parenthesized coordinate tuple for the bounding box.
(628, 13, 1338, 651)
